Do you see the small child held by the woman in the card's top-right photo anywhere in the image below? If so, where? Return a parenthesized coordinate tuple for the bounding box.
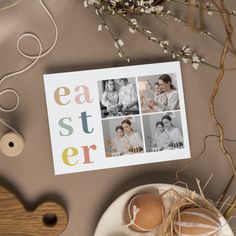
(148, 82, 168, 111)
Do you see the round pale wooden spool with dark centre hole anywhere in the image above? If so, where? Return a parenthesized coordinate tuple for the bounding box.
(0, 131, 25, 157)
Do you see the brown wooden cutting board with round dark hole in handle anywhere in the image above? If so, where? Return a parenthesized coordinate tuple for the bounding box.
(0, 186, 68, 236)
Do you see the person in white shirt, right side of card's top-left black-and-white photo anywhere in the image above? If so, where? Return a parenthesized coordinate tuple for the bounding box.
(118, 78, 138, 114)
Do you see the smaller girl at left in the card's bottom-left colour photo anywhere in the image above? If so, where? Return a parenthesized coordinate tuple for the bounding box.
(112, 125, 129, 155)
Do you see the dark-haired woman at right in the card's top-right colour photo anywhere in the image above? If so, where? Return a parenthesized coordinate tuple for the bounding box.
(158, 74, 180, 111)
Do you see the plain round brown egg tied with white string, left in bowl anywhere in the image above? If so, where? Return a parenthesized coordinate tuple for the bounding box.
(127, 193, 163, 232)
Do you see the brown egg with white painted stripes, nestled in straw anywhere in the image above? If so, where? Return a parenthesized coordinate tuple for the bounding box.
(174, 207, 221, 236)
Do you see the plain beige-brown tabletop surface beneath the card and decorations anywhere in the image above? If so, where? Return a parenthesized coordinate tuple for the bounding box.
(0, 0, 236, 236)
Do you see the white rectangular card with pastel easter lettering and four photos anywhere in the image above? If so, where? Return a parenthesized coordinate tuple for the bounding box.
(44, 62, 190, 175)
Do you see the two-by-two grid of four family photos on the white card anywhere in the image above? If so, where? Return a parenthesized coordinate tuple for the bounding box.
(98, 73, 184, 157)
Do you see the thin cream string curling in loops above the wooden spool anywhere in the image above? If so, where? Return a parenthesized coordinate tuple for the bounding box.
(0, 0, 58, 134)
